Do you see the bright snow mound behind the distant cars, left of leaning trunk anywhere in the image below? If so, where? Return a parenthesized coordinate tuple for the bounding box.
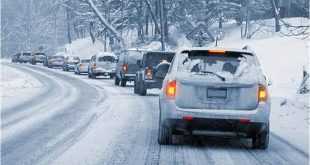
(65, 37, 104, 58)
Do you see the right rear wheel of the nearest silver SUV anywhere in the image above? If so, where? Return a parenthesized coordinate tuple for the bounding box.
(252, 124, 269, 149)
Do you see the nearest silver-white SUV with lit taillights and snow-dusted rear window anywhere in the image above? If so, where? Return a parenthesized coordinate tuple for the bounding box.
(158, 48, 271, 149)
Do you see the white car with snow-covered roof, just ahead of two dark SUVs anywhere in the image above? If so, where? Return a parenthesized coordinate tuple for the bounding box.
(88, 52, 117, 78)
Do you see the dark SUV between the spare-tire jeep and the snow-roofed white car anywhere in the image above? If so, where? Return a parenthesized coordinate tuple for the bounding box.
(115, 49, 143, 86)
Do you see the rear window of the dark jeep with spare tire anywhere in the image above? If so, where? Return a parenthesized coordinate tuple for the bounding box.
(143, 53, 174, 67)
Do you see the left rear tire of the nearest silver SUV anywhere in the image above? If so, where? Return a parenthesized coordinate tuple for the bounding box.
(158, 116, 172, 145)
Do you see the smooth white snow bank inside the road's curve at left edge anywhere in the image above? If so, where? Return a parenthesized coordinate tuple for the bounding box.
(0, 62, 42, 109)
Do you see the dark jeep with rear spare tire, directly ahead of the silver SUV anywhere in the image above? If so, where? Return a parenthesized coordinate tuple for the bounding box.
(134, 51, 175, 96)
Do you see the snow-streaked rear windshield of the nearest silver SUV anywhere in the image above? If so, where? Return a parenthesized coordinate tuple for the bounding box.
(178, 51, 256, 75)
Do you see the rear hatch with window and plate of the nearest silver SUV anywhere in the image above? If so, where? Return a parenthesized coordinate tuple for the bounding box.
(176, 49, 258, 110)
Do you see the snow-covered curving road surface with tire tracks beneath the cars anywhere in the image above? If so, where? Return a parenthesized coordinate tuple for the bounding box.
(1, 64, 309, 165)
